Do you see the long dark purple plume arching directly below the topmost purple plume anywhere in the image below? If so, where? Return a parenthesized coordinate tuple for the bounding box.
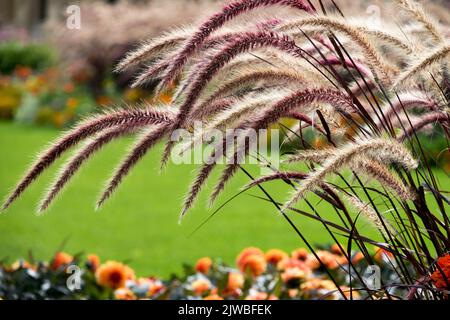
(161, 32, 318, 167)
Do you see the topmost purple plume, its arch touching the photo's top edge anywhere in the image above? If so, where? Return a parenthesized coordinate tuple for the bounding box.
(156, 0, 314, 92)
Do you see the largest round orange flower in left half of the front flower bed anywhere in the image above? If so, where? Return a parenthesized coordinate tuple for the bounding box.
(95, 261, 135, 289)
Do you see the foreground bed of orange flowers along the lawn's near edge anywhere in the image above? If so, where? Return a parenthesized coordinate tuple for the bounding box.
(0, 245, 450, 300)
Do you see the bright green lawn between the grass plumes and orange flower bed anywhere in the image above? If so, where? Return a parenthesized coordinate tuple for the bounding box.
(0, 122, 448, 275)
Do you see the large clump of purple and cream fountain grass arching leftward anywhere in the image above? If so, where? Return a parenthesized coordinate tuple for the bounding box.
(3, 0, 450, 299)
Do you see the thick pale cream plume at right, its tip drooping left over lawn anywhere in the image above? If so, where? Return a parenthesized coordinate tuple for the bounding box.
(283, 138, 417, 210)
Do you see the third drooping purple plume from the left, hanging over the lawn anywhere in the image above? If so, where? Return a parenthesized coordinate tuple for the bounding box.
(97, 123, 170, 208)
